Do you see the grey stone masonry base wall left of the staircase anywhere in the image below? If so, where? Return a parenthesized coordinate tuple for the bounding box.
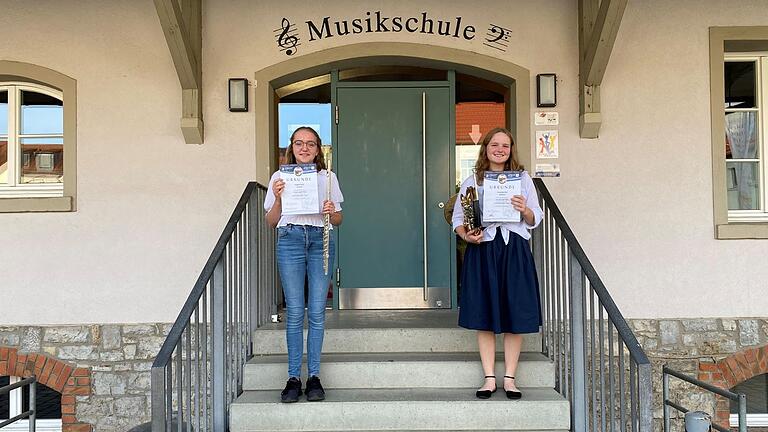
(0, 324, 170, 432)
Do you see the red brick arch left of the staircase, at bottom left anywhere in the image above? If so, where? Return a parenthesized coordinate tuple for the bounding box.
(0, 346, 93, 432)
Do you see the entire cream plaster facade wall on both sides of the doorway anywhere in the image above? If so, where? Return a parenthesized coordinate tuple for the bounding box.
(0, 0, 768, 324)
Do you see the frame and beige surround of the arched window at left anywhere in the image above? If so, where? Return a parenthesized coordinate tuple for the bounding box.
(0, 60, 77, 213)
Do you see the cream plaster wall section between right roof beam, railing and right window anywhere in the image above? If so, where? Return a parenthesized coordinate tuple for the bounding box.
(551, 0, 768, 318)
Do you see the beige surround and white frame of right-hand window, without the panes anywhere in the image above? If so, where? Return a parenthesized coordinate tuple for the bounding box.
(709, 26, 768, 239)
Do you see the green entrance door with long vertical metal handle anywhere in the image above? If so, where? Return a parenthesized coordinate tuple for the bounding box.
(335, 83, 455, 309)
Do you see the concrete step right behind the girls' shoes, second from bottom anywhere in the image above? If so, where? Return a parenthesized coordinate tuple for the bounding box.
(243, 352, 555, 390)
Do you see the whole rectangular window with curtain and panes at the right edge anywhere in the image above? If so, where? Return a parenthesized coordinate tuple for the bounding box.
(710, 27, 768, 239)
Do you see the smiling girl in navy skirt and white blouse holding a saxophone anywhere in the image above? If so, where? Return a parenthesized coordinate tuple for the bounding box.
(453, 128, 542, 399)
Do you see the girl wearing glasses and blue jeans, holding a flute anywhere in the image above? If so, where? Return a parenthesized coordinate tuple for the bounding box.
(264, 126, 344, 402)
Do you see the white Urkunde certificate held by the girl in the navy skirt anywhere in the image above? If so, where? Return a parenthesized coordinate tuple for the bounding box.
(483, 171, 522, 224)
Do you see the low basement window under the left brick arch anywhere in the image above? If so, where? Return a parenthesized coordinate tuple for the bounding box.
(0, 376, 61, 432)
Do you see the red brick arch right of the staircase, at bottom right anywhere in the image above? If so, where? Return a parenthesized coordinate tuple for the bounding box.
(698, 345, 768, 425)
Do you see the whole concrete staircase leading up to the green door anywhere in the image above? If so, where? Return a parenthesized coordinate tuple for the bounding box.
(230, 311, 570, 432)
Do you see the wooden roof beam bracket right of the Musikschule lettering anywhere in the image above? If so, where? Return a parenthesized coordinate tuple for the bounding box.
(579, 0, 627, 138)
